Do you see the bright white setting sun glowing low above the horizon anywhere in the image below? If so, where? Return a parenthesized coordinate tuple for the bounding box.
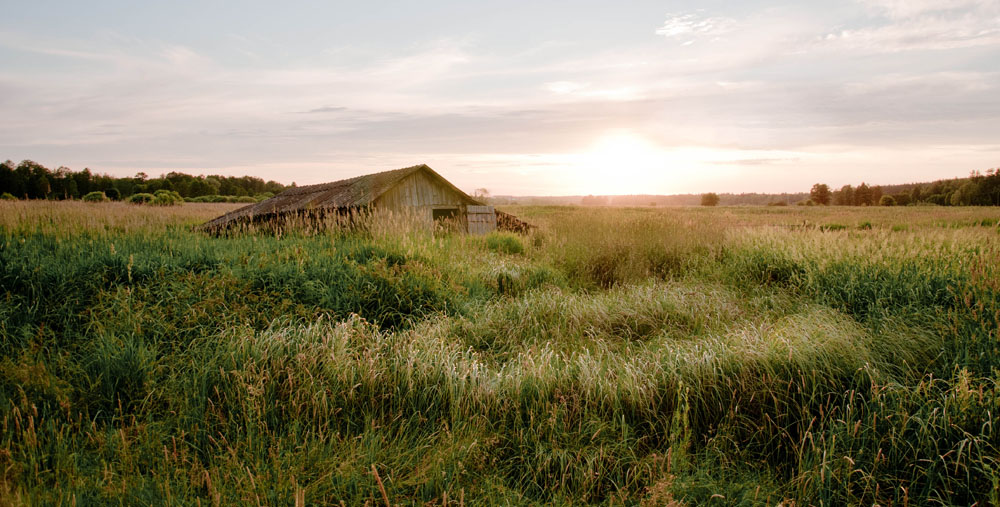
(576, 130, 670, 195)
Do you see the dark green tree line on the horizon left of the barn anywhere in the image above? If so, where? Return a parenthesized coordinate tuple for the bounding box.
(0, 160, 295, 200)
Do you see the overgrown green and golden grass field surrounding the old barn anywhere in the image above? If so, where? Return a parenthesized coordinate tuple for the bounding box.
(0, 202, 1000, 506)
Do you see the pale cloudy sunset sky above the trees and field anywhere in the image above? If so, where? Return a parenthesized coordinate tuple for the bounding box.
(0, 0, 1000, 195)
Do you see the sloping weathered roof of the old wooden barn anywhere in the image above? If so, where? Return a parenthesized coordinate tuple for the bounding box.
(202, 164, 481, 229)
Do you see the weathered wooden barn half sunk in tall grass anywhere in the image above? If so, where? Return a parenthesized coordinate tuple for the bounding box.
(202, 164, 530, 234)
